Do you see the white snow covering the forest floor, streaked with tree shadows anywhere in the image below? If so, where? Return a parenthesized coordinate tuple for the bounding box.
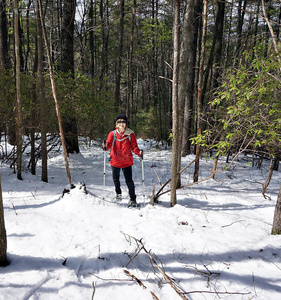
(0, 139, 281, 300)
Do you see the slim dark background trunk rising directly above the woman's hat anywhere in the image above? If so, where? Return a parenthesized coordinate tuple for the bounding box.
(115, 0, 125, 112)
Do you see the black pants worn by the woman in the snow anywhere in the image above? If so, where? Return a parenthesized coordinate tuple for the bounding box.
(111, 166, 136, 201)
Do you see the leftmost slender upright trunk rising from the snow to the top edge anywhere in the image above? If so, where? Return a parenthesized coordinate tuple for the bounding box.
(14, 0, 23, 180)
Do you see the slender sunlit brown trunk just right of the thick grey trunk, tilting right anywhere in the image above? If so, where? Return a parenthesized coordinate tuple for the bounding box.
(193, 0, 208, 182)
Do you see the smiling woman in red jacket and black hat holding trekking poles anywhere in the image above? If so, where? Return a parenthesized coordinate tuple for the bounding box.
(103, 114, 143, 207)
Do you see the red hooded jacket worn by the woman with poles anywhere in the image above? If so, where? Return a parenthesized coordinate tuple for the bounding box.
(106, 128, 140, 168)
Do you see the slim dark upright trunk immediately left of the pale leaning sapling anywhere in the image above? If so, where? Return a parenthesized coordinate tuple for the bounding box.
(36, 1, 48, 182)
